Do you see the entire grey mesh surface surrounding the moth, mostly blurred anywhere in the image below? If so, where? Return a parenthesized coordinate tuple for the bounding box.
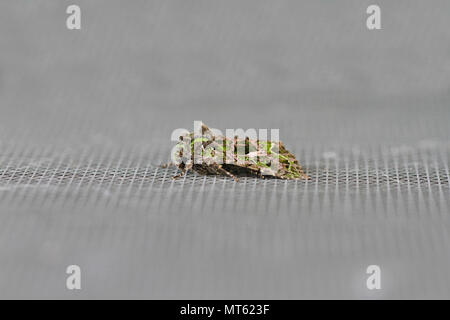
(0, 0, 450, 299)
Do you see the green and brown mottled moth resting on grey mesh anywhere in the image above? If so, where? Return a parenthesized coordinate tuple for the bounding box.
(163, 124, 309, 181)
